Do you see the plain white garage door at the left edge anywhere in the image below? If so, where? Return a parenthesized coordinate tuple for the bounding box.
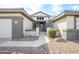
(0, 19, 12, 38)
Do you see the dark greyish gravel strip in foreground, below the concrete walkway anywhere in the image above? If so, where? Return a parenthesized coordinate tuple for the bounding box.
(0, 44, 49, 54)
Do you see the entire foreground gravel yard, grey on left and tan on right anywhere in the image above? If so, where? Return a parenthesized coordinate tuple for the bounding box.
(0, 40, 79, 54)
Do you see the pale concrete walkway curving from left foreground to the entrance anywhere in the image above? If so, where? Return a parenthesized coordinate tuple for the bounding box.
(0, 32, 49, 47)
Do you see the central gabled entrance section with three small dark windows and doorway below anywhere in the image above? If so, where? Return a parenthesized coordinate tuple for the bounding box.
(31, 11, 52, 32)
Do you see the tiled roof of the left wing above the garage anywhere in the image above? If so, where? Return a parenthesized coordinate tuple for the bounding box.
(0, 8, 34, 21)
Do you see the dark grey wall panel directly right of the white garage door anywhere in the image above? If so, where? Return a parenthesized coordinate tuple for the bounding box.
(12, 19, 23, 39)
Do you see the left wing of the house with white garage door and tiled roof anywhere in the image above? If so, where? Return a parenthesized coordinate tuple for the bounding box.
(0, 8, 34, 39)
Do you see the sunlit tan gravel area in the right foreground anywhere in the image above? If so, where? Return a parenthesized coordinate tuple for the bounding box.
(48, 40, 79, 54)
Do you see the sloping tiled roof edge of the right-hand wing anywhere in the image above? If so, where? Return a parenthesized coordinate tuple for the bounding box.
(51, 10, 79, 22)
